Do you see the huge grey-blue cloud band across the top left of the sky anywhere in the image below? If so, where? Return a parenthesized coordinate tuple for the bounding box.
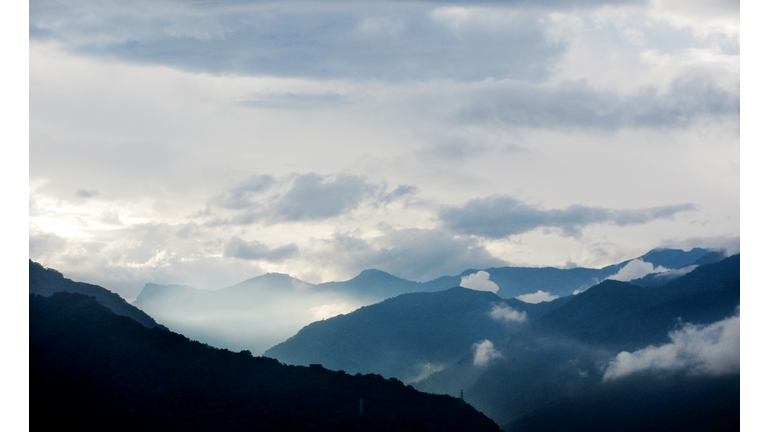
(30, 1, 568, 81)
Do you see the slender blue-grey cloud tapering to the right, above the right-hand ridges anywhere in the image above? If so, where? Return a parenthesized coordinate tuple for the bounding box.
(439, 196, 696, 239)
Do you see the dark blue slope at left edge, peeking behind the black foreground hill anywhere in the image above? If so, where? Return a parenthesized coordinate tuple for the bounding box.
(29, 260, 165, 328)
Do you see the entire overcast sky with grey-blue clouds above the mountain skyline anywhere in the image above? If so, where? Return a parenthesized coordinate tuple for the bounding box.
(29, 0, 740, 300)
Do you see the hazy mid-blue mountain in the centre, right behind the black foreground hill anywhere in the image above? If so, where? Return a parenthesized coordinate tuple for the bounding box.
(264, 287, 522, 381)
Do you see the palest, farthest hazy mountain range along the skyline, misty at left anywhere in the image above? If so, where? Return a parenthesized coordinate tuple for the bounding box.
(134, 249, 720, 353)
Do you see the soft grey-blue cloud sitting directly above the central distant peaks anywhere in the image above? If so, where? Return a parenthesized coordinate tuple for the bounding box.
(317, 228, 509, 281)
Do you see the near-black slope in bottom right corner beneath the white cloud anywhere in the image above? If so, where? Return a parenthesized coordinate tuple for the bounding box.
(504, 375, 740, 432)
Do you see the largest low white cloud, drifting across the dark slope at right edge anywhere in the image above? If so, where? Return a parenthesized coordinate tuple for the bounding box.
(603, 314, 740, 381)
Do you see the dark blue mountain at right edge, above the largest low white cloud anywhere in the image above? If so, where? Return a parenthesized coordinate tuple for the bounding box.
(534, 255, 741, 350)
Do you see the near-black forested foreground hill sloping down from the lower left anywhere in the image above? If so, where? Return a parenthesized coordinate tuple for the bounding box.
(29, 292, 499, 431)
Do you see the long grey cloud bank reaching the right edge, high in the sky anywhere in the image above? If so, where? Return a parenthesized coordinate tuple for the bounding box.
(455, 75, 740, 130)
